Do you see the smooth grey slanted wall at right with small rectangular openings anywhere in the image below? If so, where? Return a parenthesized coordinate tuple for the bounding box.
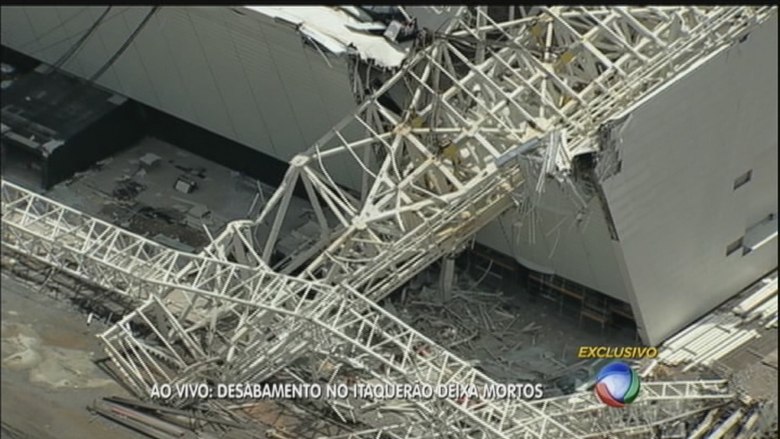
(604, 18, 778, 344)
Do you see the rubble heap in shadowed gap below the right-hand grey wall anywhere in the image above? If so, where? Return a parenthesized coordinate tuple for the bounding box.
(383, 273, 612, 395)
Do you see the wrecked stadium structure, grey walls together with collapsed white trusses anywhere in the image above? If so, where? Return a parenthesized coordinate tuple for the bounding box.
(2, 6, 778, 438)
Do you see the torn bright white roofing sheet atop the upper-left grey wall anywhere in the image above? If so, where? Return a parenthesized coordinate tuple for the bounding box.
(244, 6, 408, 67)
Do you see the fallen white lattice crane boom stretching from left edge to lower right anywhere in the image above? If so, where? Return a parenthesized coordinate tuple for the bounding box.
(2, 181, 732, 437)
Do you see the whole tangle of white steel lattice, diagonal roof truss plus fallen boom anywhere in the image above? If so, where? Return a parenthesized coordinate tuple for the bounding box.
(2, 7, 775, 438)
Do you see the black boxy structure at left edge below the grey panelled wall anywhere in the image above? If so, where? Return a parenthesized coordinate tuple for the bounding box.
(0, 64, 144, 189)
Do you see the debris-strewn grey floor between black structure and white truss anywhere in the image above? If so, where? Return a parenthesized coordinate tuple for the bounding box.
(47, 137, 296, 251)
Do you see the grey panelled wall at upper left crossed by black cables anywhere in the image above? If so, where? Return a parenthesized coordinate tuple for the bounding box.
(0, 6, 355, 167)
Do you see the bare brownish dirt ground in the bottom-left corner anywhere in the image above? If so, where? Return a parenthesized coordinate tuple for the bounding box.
(0, 272, 145, 439)
